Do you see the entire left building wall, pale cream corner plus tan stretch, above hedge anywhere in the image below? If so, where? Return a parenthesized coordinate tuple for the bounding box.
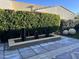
(0, 0, 42, 11)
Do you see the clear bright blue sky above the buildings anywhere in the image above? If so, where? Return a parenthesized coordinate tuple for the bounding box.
(16, 0, 79, 13)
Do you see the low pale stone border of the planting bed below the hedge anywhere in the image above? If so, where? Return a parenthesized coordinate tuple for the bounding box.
(8, 35, 61, 49)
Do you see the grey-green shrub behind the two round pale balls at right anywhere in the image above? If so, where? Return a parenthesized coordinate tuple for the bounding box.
(61, 19, 79, 30)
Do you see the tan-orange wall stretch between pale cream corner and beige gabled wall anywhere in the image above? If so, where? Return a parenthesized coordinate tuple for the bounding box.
(12, 1, 42, 11)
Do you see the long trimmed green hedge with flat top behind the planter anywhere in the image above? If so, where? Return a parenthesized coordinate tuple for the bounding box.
(0, 9, 60, 42)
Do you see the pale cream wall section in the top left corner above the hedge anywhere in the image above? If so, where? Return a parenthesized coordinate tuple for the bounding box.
(0, 0, 12, 9)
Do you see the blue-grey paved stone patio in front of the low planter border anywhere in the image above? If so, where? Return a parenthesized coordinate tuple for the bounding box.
(0, 37, 79, 59)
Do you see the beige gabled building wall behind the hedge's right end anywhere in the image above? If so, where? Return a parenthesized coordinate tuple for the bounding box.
(36, 6, 76, 20)
